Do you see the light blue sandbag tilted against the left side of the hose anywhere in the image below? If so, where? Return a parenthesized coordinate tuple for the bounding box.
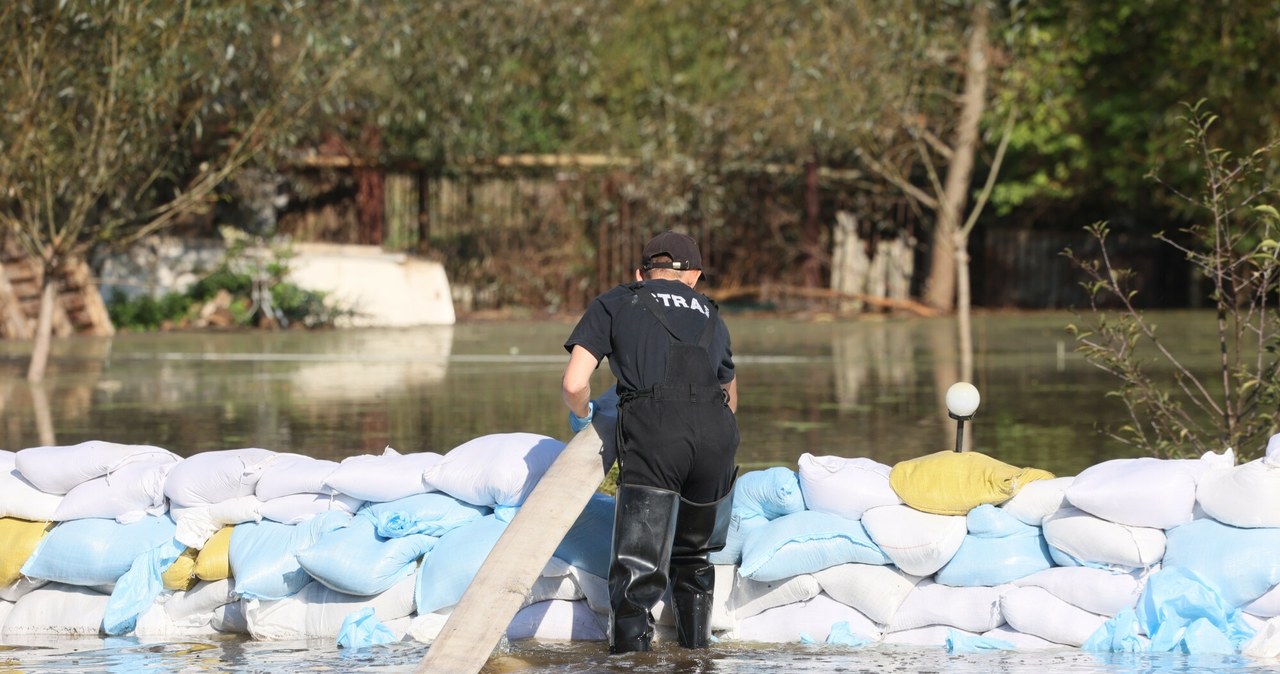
(413, 515, 507, 615)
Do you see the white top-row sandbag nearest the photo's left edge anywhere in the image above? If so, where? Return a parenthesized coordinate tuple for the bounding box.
(14, 440, 180, 494)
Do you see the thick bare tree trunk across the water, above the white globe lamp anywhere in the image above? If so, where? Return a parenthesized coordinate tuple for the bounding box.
(924, 0, 988, 311)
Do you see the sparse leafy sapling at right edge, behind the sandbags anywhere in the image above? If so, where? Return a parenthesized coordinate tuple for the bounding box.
(1065, 104, 1280, 459)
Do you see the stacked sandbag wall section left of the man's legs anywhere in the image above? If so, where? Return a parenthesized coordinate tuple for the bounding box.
(0, 434, 613, 641)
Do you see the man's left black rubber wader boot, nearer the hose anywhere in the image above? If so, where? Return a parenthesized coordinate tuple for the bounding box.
(609, 485, 680, 654)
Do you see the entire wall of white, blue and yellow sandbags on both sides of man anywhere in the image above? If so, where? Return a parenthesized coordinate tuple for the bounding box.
(0, 434, 1280, 657)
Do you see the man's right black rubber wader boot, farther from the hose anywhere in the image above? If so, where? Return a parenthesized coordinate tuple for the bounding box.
(671, 487, 733, 648)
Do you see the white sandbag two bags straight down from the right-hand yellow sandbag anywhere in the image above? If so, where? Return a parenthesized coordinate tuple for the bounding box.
(886, 578, 1011, 632)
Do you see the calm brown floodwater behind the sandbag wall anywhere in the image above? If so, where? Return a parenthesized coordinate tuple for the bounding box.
(0, 313, 1228, 474)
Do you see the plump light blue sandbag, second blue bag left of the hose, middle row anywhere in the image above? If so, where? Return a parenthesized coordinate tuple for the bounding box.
(297, 516, 437, 597)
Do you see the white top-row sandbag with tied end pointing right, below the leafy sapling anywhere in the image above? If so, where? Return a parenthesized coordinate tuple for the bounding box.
(1066, 450, 1235, 529)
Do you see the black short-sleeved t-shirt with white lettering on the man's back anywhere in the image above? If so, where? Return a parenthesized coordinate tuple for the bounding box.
(564, 279, 733, 393)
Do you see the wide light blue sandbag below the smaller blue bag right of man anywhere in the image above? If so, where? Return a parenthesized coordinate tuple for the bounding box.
(739, 510, 890, 581)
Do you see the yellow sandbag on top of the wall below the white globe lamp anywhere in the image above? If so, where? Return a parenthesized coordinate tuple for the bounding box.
(888, 450, 1053, 515)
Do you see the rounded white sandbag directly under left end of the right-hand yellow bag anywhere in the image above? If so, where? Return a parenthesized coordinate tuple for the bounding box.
(861, 505, 969, 576)
